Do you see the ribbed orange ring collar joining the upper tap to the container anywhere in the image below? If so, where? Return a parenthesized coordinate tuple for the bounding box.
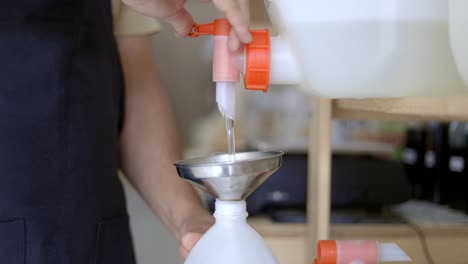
(244, 29, 271, 92)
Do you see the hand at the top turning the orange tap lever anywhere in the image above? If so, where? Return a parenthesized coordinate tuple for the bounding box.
(123, 0, 252, 51)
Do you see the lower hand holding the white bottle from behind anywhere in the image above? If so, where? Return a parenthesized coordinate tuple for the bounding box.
(177, 211, 214, 261)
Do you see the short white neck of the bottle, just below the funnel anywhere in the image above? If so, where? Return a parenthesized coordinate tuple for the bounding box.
(214, 200, 248, 222)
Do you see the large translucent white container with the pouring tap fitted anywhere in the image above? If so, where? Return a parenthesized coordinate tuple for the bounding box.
(266, 0, 468, 98)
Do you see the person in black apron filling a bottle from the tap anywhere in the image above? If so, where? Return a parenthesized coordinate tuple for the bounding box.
(0, 0, 249, 264)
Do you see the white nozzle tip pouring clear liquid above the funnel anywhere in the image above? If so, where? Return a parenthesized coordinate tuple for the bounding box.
(216, 82, 236, 120)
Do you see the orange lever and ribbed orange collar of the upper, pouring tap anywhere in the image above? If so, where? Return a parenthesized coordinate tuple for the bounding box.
(188, 19, 271, 92)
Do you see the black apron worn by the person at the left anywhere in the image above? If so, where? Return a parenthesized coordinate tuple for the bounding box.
(0, 0, 134, 264)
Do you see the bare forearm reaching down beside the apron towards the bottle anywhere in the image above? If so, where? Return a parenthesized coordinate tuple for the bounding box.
(118, 34, 209, 238)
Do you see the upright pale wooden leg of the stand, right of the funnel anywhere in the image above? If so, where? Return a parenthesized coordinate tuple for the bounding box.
(306, 98, 332, 263)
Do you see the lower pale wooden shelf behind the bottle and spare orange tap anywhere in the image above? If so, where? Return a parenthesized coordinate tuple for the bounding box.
(249, 218, 468, 264)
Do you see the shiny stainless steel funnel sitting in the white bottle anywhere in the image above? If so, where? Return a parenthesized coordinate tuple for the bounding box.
(175, 151, 283, 201)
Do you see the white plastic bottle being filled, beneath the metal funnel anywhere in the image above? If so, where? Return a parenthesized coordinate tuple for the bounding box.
(185, 200, 278, 264)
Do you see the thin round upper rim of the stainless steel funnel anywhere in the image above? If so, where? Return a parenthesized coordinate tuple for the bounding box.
(174, 150, 284, 167)
